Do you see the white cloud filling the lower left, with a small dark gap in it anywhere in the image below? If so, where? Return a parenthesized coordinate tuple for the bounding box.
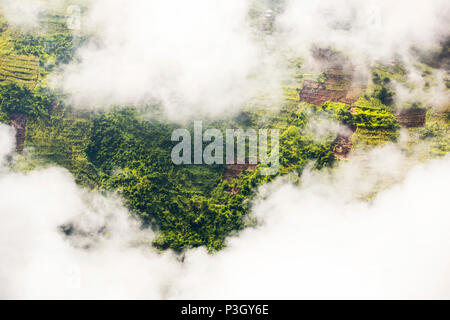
(0, 126, 177, 299)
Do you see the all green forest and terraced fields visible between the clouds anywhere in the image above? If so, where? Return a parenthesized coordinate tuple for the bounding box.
(0, 3, 450, 250)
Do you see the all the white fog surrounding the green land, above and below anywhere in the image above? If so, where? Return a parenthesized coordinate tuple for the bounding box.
(0, 0, 450, 299)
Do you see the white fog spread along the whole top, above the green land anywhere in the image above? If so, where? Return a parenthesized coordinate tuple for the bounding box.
(0, 0, 450, 116)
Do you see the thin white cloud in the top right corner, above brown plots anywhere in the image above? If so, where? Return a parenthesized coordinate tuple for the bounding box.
(277, 0, 450, 64)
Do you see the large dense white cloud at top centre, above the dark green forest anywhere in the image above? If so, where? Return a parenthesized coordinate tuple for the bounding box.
(53, 0, 284, 120)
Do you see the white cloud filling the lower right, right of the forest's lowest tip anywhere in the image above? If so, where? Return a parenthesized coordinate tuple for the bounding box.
(176, 153, 450, 299)
